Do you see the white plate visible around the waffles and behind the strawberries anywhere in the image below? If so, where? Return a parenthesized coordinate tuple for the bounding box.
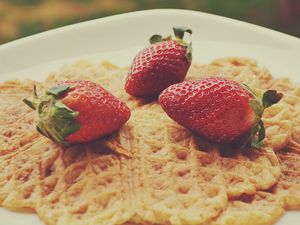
(0, 10, 300, 225)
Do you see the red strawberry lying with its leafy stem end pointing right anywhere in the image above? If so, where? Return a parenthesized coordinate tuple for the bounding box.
(159, 77, 282, 148)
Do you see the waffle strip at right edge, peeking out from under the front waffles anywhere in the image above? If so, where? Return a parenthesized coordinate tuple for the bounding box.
(271, 79, 300, 209)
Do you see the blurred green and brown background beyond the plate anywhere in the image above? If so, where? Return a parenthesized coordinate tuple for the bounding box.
(0, 0, 300, 44)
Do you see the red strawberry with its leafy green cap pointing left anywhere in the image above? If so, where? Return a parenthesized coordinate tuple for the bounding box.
(23, 80, 130, 146)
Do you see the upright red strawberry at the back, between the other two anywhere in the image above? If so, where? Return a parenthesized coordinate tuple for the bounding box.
(125, 27, 192, 98)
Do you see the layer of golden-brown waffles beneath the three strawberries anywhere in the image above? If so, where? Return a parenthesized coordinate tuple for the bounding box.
(0, 58, 299, 225)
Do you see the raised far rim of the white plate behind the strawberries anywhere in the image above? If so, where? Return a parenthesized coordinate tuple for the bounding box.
(0, 9, 300, 76)
